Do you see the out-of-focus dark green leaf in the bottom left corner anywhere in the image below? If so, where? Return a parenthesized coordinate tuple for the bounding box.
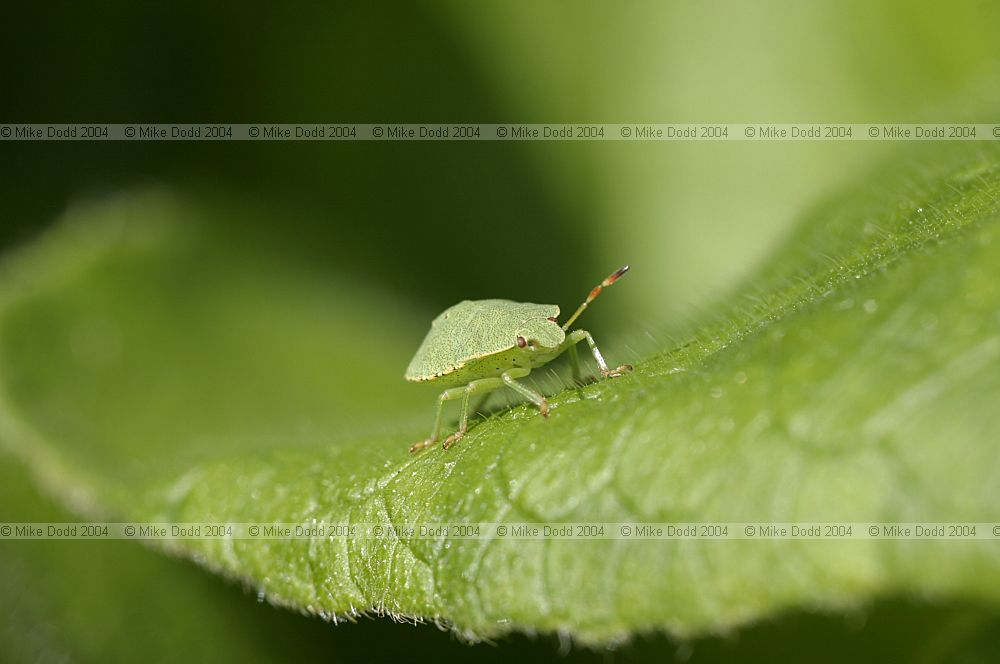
(0, 438, 362, 662)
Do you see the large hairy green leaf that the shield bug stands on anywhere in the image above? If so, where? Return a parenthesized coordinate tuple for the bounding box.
(0, 144, 1000, 641)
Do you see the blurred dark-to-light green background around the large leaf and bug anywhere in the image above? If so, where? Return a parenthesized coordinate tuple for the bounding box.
(0, 1, 1000, 661)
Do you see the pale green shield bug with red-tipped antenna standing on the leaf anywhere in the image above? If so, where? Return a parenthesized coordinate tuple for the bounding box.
(406, 265, 632, 453)
